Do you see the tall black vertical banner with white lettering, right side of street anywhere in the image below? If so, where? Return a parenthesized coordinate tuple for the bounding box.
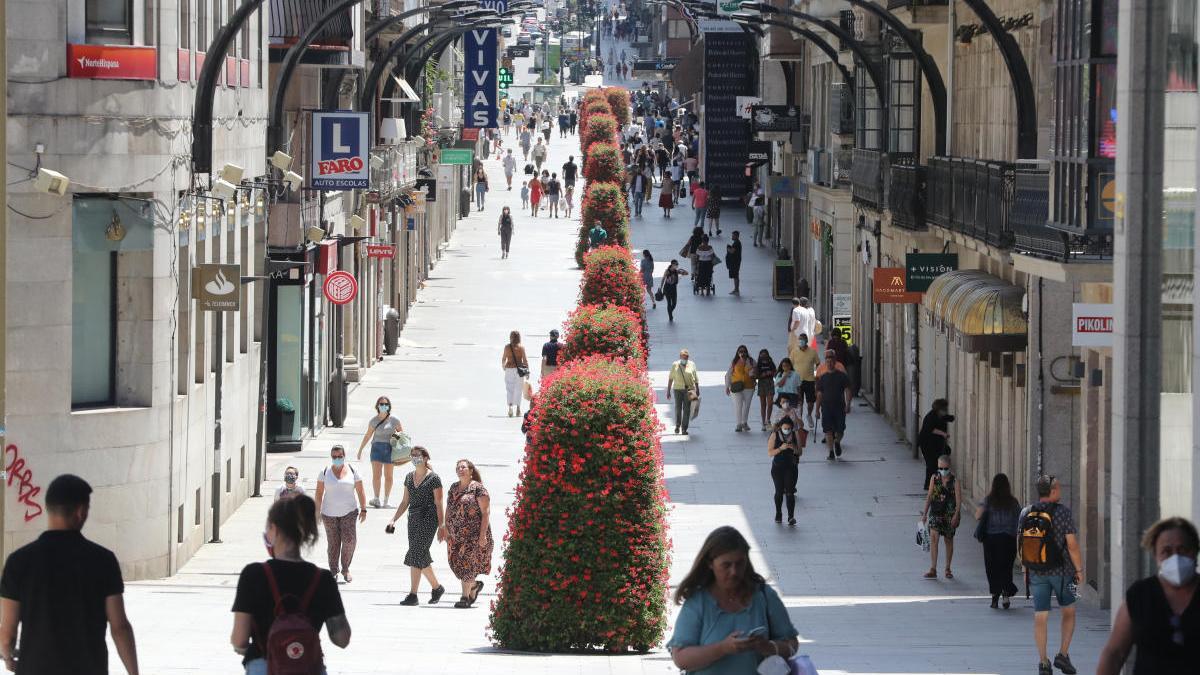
(702, 31, 751, 197)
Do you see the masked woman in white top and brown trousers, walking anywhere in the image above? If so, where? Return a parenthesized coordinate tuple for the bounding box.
(317, 446, 367, 584)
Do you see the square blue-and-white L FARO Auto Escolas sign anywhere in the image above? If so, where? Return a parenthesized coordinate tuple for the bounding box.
(310, 110, 371, 190)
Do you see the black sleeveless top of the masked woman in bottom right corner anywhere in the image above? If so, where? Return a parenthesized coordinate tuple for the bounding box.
(1126, 577, 1200, 675)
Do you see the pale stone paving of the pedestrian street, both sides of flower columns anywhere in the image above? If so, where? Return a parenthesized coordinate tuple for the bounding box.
(113, 40, 1108, 675)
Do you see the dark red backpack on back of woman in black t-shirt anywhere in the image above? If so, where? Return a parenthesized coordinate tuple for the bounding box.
(263, 562, 324, 675)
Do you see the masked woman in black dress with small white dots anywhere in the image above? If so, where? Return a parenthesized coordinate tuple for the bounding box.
(386, 446, 446, 605)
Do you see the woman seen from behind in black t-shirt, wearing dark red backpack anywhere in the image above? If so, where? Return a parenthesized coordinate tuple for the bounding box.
(229, 495, 350, 675)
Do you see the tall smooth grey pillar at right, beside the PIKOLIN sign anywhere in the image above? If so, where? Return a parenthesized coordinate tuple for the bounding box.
(1110, 0, 1168, 610)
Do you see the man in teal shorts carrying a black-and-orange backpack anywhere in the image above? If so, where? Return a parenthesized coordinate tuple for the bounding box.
(1016, 476, 1084, 675)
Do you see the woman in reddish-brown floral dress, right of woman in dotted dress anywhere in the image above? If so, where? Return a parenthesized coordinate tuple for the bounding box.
(446, 459, 494, 609)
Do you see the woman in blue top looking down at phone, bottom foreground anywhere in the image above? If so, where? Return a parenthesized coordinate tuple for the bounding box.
(667, 526, 799, 675)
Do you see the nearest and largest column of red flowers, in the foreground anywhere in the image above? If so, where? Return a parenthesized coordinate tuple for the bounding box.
(490, 357, 670, 651)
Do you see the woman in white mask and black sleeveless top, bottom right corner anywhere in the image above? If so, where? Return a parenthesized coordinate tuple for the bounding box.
(1096, 518, 1200, 675)
